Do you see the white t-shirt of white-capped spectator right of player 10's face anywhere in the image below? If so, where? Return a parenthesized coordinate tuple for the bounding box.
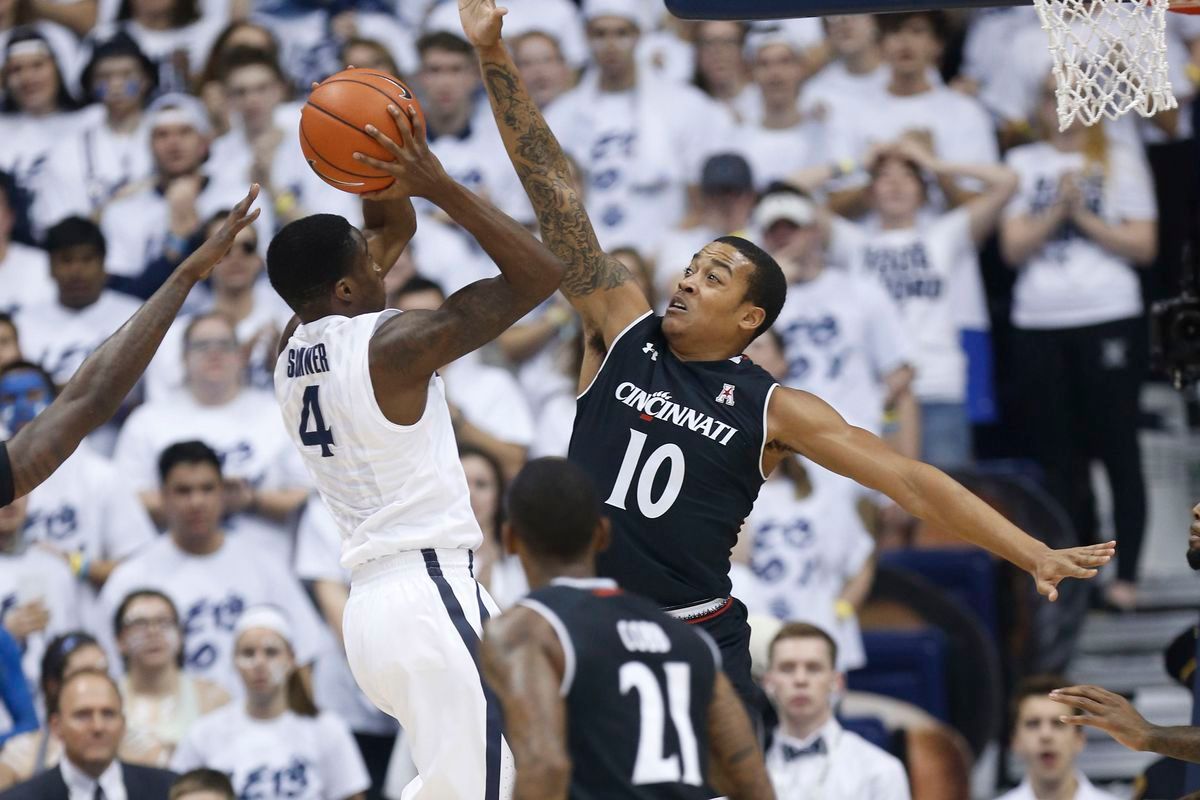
(775, 267, 912, 433)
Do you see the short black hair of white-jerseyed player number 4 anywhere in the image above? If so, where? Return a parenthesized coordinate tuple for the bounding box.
(266, 213, 361, 312)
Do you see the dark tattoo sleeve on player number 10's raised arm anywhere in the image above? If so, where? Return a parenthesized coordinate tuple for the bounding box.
(484, 61, 631, 297)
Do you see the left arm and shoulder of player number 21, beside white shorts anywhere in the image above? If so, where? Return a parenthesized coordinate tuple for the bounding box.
(479, 606, 571, 800)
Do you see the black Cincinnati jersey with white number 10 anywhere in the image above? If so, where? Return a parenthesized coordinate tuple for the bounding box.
(570, 314, 775, 607)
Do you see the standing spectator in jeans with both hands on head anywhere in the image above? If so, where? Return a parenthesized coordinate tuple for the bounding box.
(829, 139, 1016, 469)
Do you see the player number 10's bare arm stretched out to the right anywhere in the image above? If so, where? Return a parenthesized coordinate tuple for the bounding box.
(764, 387, 1116, 600)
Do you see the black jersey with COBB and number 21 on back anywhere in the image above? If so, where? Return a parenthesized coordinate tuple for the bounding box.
(520, 578, 720, 800)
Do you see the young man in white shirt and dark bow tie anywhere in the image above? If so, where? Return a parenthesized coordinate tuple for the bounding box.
(763, 622, 910, 800)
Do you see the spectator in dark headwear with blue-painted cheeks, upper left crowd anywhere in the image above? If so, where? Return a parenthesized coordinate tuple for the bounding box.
(30, 32, 157, 230)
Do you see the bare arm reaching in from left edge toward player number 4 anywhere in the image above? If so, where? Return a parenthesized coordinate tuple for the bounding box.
(0, 185, 258, 498)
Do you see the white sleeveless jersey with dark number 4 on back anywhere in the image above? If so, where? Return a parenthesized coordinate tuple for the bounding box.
(275, 308, 484, 570)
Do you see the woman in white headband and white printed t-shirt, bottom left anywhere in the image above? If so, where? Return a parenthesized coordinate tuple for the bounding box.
(172, 606, 370, 800)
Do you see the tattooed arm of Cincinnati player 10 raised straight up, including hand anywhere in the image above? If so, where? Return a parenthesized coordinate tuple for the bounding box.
(458, 0, 650, 349)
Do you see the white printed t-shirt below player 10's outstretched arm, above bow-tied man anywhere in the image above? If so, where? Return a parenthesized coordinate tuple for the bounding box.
(738, 463, 875, 672)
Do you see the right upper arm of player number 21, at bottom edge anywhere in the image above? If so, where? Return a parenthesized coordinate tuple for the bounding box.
(708, 672, 775, 800)
